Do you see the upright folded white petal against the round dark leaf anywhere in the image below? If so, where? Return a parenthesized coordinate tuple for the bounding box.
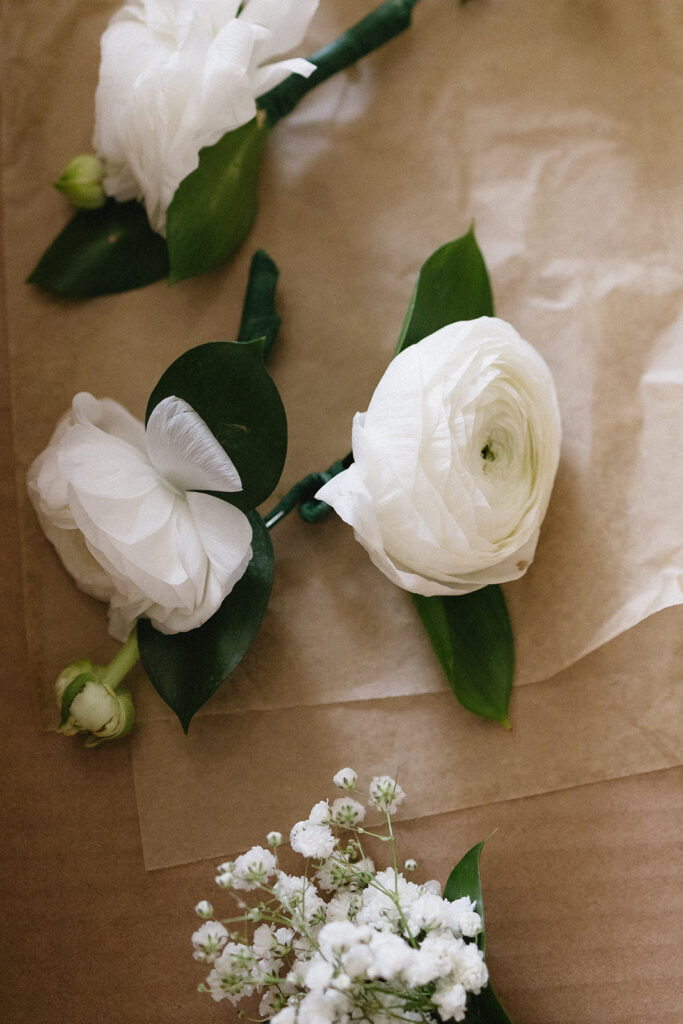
(146, 395, 242, 492)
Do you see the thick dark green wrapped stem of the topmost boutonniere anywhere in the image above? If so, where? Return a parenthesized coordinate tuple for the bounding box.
(257, 0, 418, 128)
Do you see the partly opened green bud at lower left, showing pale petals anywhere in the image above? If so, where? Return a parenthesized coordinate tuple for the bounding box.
(54, 659, 134, 746)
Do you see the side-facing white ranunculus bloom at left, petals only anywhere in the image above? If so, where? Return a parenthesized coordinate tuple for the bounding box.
(28, 392, 252, 641)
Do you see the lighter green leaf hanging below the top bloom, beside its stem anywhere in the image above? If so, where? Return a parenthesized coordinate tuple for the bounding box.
(166, 114, 268, 284)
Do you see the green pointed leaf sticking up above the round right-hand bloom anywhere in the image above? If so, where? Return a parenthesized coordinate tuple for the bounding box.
(394, 227, 494, 355)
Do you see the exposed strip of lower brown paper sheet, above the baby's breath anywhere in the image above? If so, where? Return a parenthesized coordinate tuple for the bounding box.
(133, 609, 683, 868)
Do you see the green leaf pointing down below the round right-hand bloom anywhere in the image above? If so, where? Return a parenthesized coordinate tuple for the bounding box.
(412, 586, 514, 728)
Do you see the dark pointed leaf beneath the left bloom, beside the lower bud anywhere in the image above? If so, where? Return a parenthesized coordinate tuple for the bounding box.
(137, 520, 273, 732)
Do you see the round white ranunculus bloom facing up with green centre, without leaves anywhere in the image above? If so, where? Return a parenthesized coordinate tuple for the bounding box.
(316, 316, 561, 596)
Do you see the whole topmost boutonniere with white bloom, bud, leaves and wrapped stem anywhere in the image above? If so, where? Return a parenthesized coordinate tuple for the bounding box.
(29, 0, 430, 298)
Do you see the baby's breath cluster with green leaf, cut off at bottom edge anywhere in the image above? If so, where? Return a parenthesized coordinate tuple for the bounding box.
(191, 768, 510, 1024)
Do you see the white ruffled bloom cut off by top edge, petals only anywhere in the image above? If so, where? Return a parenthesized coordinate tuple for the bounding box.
(93, 0, 318, 234)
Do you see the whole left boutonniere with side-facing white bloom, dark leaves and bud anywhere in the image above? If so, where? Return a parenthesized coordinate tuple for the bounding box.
(28, 253, 287, 743)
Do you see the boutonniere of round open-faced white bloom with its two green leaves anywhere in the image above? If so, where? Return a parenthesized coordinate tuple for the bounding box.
(315, 230, 561, 726)
